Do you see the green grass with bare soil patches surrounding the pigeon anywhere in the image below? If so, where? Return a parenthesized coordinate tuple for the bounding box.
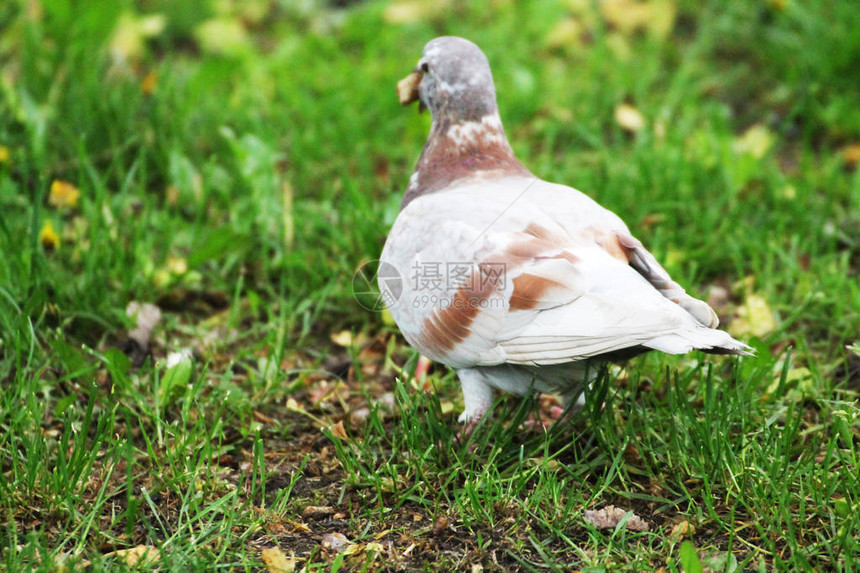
(0, 0, 860, 572)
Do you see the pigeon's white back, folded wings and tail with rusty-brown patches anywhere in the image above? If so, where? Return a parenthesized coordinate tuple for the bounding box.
(383, 180, 746, 367)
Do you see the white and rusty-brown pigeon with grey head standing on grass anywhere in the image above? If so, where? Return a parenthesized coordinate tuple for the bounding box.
(379, 36, 752, 420)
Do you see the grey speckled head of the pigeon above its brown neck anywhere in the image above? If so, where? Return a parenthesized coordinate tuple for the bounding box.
(417, 36, 497, 123)
